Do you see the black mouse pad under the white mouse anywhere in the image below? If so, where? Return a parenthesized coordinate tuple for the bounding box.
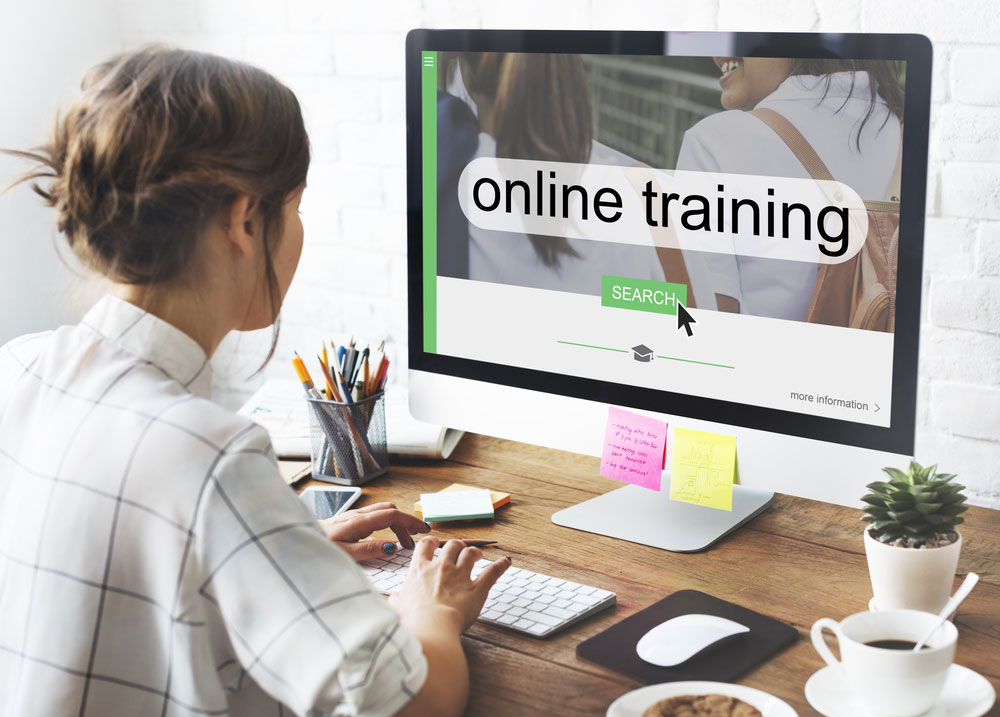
(576, 590, 799, 683)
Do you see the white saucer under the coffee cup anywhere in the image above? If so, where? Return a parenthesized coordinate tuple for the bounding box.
(806, 665, 996, 717)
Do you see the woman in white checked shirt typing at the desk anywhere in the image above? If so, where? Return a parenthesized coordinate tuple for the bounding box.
(0, 48, 510, 715)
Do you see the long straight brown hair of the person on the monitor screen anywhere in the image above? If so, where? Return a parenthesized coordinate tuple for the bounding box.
(461, 52, 594, 268)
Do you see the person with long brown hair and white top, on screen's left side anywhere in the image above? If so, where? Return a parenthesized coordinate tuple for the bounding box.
(448, 52, 686, 295)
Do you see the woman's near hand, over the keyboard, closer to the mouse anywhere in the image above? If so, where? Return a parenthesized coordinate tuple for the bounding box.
(389, 537, 510, 635)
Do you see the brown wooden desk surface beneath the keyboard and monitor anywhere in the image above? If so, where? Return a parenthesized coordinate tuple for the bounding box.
(286, 435, 1000, 717)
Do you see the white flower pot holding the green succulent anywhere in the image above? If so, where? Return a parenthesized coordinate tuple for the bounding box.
(864, 527, 962, 613)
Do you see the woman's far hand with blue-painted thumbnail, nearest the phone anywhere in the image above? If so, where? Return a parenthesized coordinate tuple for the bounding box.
(319, 503, 430, 562)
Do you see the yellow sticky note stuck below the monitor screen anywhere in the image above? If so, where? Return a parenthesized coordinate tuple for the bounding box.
(670, 428, 736, 510)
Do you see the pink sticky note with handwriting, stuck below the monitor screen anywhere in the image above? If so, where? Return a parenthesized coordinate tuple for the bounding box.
(601, 406, 667, 490)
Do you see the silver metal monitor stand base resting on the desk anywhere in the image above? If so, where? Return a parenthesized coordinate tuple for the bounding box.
(552, 485, 774, 553)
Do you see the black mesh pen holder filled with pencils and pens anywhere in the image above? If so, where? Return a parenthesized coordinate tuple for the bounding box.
(306, 391, 389, 485)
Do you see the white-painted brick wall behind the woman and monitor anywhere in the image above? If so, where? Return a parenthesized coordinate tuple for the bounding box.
(111, 0, 1000, 507)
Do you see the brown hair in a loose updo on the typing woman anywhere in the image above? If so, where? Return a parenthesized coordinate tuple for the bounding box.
(9, 46, 309, 352)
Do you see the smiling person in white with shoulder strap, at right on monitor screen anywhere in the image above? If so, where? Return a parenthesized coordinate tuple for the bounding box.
(677, 57, 903, 321)
